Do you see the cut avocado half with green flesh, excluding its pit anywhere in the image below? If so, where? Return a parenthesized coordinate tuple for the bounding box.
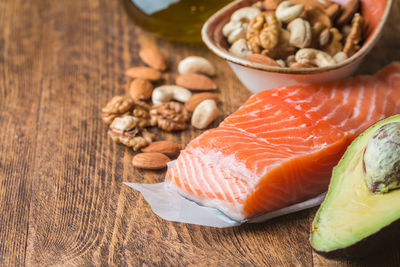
(310, 115, 400, 258)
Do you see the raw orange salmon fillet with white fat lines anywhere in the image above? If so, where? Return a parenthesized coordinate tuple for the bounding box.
(168, 63, 400, 220)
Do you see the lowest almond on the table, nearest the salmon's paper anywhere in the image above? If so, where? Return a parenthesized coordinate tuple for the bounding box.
(132, 153, 171, 170)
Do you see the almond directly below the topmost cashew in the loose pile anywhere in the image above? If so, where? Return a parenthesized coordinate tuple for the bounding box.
(175, 73, 217, 90)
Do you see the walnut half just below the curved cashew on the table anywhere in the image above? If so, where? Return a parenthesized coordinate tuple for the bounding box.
(150, 102, 190, 131)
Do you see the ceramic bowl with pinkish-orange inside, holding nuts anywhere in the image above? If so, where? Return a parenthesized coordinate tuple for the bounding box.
(202, 0, 392, 93)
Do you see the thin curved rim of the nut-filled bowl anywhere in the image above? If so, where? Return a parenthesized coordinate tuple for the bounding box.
(201, 0, 393, 74)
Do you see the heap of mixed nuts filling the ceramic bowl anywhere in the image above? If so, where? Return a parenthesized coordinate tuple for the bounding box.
(222, 0, 364, 68)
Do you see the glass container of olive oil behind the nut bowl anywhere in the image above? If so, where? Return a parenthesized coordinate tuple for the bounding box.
(122, 0, 232, 42)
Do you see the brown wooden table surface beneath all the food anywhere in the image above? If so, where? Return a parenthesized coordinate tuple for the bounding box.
(0, 0, 400, 266)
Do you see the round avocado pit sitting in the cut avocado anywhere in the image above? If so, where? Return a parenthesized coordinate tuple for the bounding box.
(363, 122, 400, 194)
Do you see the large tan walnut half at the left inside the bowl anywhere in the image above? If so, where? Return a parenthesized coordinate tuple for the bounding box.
(246, 12, 281, 53)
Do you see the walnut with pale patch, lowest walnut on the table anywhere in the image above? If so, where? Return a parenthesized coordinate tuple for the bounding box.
(108, 115, 155, 151)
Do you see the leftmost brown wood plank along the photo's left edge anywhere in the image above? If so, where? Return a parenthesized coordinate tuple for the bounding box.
(0, 1, 43, 266)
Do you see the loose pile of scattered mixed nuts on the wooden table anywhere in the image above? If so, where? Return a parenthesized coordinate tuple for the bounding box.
(102, 48, 219, 170)
